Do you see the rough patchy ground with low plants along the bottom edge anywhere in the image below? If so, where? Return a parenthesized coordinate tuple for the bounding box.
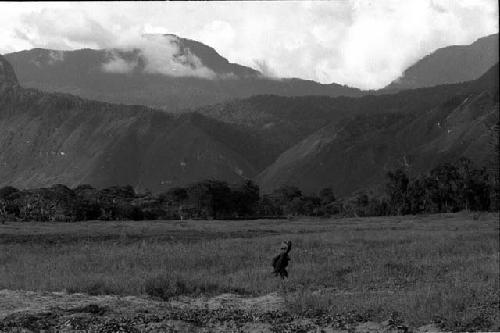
(0, 290, 441, 333)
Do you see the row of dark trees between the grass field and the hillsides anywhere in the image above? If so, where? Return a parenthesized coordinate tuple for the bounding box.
(0, 158, 499, 222)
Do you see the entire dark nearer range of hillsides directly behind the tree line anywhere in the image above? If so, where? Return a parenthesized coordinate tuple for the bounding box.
(0, 52, 498, 195)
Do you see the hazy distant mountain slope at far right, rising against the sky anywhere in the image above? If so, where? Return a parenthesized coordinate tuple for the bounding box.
(384, 34, 498, 91)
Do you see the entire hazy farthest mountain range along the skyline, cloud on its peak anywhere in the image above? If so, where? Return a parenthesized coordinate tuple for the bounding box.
(5, 34, 498, 109)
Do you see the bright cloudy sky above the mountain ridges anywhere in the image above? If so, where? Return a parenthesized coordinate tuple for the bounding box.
(0, 0, 499, 89)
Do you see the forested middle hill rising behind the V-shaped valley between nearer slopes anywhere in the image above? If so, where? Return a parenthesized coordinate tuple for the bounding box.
(193, 78, 472, 156)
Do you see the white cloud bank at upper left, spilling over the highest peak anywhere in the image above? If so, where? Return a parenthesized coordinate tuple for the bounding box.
(11, 9, 216, 79)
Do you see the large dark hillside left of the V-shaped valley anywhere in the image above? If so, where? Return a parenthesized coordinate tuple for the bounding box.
(0, 56, 282, 192)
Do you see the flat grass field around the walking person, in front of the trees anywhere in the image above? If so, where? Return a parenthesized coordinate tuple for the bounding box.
(0, 213, 500, 330)
